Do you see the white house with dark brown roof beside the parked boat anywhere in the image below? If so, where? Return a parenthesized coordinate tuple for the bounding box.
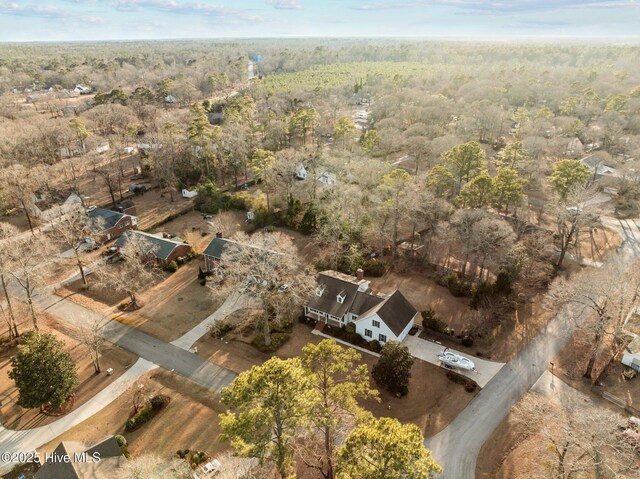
(304, 270, 418, 344)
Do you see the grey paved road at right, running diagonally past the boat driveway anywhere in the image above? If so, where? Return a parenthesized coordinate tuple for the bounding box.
(424, 217, 640, 479)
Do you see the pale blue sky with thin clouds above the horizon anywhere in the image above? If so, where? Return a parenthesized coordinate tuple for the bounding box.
(0, 0, 640, 41)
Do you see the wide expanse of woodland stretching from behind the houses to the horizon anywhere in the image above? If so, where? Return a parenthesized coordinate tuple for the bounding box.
(0, 40, 640, 342)
